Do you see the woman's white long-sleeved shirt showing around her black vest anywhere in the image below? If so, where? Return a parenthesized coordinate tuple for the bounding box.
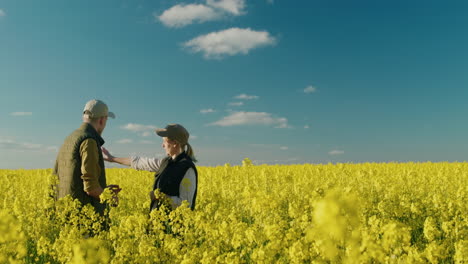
(131, 156, 197, 209)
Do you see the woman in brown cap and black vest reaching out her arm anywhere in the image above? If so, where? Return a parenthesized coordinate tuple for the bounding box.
(102, 124, 198, 210)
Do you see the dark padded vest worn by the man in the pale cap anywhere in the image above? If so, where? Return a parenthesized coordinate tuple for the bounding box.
(54, 123, 107, 214)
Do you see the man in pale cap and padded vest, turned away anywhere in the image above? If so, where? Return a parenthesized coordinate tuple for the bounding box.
(54, 100, 120, 215)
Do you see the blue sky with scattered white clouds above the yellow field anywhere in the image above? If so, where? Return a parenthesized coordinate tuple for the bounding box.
(0, 0, 468, 169)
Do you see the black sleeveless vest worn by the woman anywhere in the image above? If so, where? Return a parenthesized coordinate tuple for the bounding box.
(153, 152, 198, 210)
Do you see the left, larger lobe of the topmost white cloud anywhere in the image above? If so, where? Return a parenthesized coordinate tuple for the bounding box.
(157, 4, 220, 28)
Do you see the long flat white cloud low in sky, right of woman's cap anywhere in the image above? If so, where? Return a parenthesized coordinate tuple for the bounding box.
(210, 112, 289, 128)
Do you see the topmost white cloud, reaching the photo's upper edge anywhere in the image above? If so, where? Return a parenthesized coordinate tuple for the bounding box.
(157, 0, 245, 28)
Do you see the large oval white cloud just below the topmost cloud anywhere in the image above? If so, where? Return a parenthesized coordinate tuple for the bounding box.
(183, 28, 276, 59)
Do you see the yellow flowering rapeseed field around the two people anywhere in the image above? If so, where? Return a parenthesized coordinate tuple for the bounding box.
(0, 159, 468, 264)
